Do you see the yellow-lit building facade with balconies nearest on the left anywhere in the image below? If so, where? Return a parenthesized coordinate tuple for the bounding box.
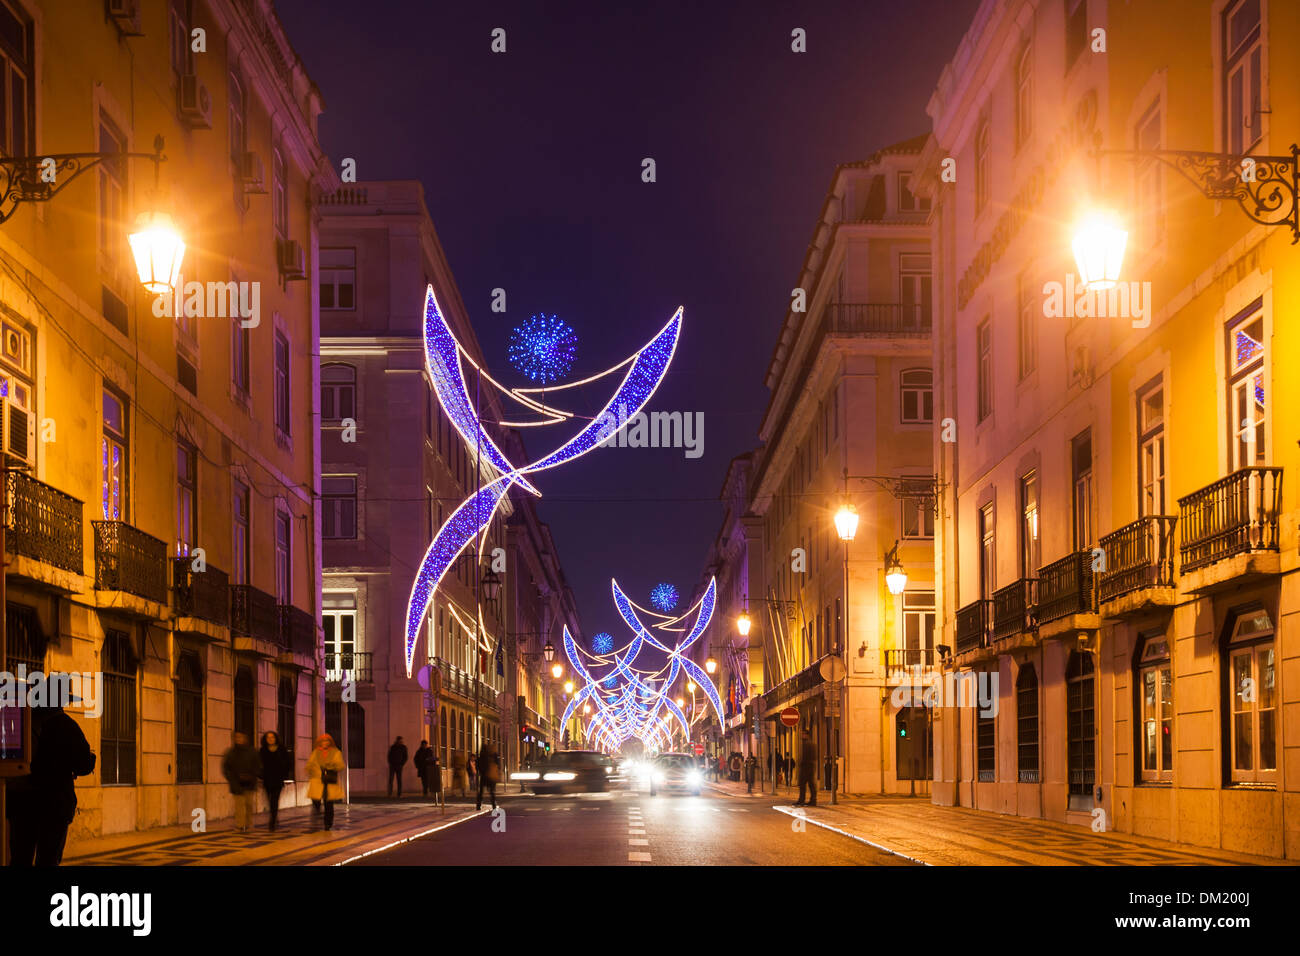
(0, 0, 333, 845)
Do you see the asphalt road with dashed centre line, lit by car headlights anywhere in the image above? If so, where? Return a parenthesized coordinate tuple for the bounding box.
(351, 788, 913, 866)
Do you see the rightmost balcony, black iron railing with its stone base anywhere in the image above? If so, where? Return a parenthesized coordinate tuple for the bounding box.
(1178, 468, 1282, 592)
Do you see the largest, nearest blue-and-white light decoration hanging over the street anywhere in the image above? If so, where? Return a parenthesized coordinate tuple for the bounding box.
(406, 285, 681, 678)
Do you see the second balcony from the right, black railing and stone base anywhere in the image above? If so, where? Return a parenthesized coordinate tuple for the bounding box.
(1097, 515, 1178, 618)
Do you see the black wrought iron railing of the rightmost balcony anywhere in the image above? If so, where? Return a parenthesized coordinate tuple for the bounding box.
(1178, 468, 1282, 574)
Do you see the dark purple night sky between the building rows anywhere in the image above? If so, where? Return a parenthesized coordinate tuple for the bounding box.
(276, 0, 978, 643)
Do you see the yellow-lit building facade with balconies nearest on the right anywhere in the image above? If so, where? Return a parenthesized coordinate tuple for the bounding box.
(923, 0, 1300, 857)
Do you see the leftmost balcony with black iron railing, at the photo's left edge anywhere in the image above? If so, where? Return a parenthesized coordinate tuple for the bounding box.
(5, 471, 85, 592)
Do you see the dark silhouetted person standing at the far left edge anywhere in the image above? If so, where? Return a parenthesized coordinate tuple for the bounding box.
(5, 706, 95, 866)
